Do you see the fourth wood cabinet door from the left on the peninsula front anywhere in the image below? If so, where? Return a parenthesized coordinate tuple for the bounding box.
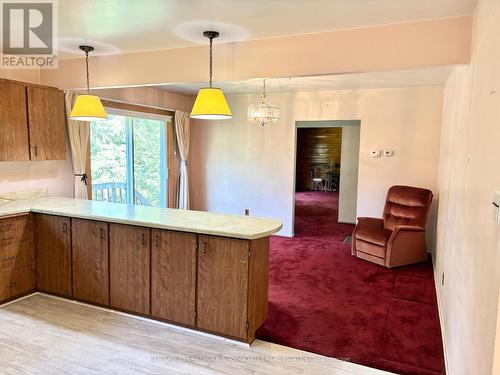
(151, 229, 198, 326)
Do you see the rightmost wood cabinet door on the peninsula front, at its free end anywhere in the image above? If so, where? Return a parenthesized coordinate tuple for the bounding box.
(197, 236, 249, 339)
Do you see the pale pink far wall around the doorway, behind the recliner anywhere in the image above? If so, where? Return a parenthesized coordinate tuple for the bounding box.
(190, 86, 443, 241)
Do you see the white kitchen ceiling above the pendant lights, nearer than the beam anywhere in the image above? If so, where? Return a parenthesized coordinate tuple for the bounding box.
(58, 0, 477, 57)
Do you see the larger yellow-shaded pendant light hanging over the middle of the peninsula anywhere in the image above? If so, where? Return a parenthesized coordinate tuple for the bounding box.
(191, 31, 233, 120)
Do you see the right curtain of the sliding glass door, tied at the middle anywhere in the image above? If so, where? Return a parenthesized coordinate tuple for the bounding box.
(174, 111, 189, 210)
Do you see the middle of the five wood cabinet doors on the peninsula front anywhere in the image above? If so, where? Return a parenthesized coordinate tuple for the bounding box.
(109, 224, 151, 315)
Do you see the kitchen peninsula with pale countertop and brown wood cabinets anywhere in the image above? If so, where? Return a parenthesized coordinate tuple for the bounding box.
(0, 197, 282, 343)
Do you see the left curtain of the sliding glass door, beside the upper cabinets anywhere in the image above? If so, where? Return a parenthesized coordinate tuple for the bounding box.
(65, 92, 90, 199)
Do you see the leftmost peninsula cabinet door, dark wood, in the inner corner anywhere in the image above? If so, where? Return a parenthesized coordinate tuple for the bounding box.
(35, 214, 71, 296)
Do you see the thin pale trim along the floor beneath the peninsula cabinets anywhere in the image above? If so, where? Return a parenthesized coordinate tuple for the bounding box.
(24, 292, 251, 348)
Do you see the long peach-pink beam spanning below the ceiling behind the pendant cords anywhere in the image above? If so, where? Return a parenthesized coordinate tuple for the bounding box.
(41, 16, 472, 89)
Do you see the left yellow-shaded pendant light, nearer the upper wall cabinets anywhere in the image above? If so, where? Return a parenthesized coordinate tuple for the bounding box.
(69, 46, 108, 121)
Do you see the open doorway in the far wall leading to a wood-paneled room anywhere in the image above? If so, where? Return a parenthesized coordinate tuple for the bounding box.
(294, 120, 361, 233)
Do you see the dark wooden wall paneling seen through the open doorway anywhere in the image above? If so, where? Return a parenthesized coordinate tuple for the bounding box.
(296, 127, 342, 191)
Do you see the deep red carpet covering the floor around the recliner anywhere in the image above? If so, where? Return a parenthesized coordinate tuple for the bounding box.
(258, 192, 444, 375)
